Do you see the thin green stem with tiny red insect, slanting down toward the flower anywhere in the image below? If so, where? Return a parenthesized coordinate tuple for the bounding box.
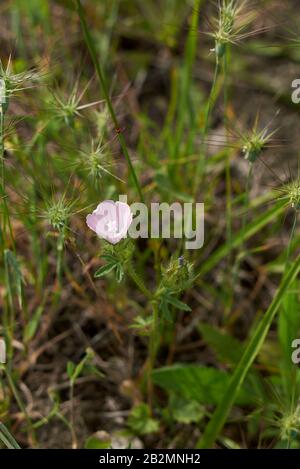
(76, 0, 144, 202)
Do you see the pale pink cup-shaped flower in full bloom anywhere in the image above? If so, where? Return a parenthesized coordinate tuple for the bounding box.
(86, 200, 132, 244)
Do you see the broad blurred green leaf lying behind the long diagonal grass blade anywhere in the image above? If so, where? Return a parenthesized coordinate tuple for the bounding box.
(152, 364, 253, 405)
